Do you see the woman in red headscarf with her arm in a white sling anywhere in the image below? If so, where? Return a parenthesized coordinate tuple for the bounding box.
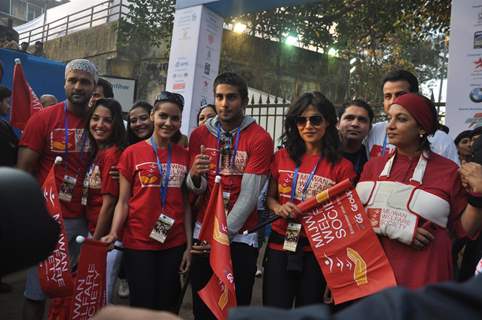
(356, 93, 482, 288)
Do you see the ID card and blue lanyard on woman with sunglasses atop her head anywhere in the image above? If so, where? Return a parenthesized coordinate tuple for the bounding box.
(149, 136, 176, 243)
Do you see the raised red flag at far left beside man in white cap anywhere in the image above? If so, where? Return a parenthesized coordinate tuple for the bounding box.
(11, 59, 42, 129)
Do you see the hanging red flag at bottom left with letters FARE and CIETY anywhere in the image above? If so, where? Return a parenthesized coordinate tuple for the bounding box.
(69, 239, 108, 320)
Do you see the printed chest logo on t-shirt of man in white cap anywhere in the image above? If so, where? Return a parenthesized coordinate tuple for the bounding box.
(50, 128, 89, 153)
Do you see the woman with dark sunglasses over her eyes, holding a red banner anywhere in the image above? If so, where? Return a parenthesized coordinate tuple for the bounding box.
(263, 92, 356, 308)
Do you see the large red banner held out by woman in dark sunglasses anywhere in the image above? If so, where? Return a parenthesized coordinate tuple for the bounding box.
(302, 184, 397, 304)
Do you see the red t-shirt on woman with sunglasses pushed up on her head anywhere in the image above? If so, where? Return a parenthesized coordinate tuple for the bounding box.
(118, 141, 189, 250)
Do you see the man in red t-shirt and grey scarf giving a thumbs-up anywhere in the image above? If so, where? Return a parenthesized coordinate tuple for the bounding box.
(187, 73, 273, 320)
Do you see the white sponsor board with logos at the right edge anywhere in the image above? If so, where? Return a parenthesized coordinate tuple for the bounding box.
(446, 0, 482, 137)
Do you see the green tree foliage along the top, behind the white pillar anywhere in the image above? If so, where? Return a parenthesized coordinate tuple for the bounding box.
(120, 0, 451, 102)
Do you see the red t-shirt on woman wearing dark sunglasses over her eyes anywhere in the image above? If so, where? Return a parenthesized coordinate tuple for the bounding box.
(269, 149, 356, 251)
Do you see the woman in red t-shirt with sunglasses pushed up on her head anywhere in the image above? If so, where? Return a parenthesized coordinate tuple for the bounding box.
(102, 91, 192, 312)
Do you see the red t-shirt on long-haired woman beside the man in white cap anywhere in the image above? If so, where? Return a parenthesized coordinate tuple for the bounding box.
(85, 146, 122, 234)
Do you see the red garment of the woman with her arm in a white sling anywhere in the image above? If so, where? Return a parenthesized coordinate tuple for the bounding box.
(360, 152, 467, 288)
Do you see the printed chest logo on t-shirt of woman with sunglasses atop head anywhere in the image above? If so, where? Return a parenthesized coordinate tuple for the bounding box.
(136, 162, 187, 188)
